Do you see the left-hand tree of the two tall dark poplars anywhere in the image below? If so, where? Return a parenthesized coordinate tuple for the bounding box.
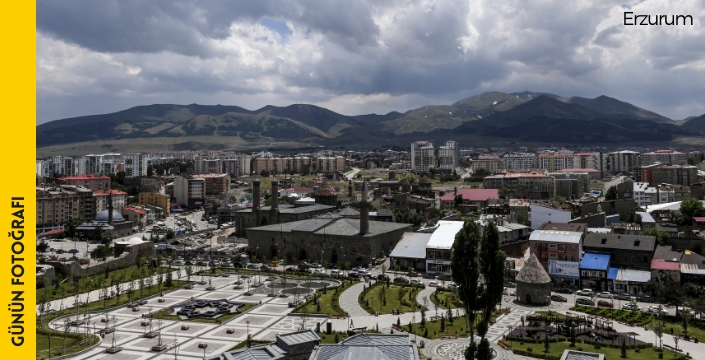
(450, 221, 480, 359)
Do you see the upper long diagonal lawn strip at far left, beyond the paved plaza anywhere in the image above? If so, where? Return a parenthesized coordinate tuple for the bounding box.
(37, 265, 176, 302)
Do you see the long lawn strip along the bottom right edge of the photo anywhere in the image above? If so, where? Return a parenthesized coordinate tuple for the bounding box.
(507, 341, 684, 360)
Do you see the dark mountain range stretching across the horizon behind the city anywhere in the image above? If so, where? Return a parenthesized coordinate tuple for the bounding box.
(37, 91, 705, 155)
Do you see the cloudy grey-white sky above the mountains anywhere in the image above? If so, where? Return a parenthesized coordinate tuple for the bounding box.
(37, 0, 705, 123)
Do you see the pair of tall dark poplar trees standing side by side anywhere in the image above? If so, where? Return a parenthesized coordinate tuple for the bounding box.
(450, 221, 507, 360)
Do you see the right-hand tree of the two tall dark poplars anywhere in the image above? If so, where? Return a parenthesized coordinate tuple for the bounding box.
(477, 221, 507, 360)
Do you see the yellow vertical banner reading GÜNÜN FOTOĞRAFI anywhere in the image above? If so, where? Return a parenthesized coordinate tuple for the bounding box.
(0, 1, 37, 359)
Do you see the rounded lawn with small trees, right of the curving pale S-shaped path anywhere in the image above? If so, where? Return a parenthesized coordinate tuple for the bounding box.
(358, 283, 422, 314)
